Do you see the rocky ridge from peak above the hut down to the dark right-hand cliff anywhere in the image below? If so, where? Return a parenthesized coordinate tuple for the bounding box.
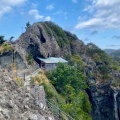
(0, 22, 120, 120)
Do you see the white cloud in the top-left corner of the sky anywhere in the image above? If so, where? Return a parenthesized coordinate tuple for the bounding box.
(0, 0, 27, 17)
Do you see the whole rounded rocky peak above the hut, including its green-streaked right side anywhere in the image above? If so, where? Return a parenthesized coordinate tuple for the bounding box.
(16, 22, 85, 58)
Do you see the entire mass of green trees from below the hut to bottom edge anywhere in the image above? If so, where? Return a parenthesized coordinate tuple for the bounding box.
(47, 63, 91, 120)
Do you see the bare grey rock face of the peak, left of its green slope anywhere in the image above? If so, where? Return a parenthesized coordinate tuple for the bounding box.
(17, 23, 61, 57)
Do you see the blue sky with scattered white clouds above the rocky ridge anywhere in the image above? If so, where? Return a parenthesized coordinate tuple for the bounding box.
(0, 0, 120, 49)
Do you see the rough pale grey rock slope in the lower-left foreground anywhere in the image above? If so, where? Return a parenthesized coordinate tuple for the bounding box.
(0, 70, 54, 120)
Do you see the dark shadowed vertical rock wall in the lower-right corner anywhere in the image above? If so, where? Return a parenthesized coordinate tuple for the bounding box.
(88, 84, 120, 120)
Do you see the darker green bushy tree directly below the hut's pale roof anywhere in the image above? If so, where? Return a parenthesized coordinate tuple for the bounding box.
(49, 63, 83, 94)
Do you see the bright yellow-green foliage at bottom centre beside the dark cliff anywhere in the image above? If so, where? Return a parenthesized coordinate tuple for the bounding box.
(63, 91, 91, 120)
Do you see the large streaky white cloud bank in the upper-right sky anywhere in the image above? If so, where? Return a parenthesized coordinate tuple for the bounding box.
(75, 0, 120, 29)
